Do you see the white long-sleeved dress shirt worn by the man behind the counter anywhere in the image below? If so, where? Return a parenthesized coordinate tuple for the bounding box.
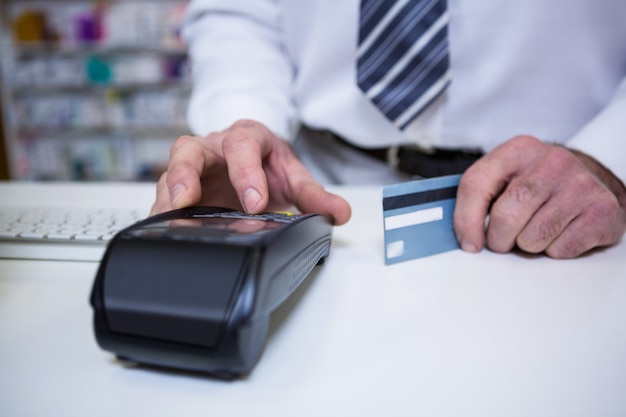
(184, 0, 626, 180)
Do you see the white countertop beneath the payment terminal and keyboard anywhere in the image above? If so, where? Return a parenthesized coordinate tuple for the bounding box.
(0, 183, 626, 417)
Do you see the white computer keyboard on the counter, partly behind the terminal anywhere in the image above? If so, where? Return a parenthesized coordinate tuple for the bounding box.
(0, 207, 148, 261)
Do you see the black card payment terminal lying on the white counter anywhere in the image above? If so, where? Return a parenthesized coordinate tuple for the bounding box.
(91, 207, 332, 378)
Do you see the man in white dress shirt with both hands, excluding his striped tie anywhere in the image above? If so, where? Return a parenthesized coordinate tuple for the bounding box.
(153, 0, 626, 258)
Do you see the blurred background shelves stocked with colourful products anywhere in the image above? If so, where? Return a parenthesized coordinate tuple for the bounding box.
(0, 0, 190, 181)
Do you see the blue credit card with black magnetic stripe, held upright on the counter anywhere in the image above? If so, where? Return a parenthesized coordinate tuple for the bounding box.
(383, 175, 461, 265)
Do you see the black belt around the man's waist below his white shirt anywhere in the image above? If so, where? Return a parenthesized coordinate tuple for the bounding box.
(333, 134, 484, 178)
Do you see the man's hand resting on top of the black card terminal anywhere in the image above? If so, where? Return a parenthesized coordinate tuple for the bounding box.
(151, 120, 351, 225)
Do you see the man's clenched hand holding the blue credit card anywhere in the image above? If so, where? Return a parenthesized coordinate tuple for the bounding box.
(454, 136, 626, 258)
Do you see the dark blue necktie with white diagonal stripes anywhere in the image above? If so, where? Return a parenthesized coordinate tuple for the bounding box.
(357, 0, 450, 129)
